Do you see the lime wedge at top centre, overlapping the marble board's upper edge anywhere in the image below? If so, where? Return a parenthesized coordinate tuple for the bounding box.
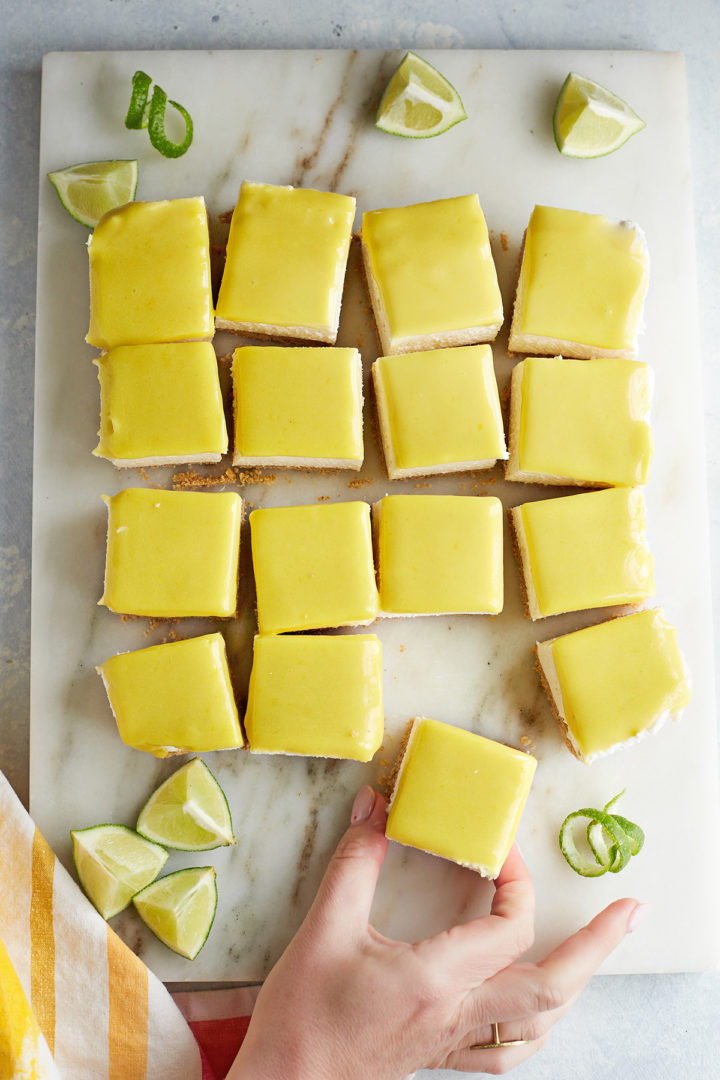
(375, 53, 467, 138)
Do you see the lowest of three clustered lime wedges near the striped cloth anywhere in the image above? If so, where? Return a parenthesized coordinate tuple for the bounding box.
(133, 866, 217, 960)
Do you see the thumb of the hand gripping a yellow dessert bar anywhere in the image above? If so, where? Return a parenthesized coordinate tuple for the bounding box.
(308, 786, 389, 937)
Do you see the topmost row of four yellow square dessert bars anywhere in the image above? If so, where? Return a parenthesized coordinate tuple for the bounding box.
(87, 183, 648, 360)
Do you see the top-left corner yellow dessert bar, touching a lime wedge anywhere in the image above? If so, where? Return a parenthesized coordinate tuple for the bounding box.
(86, 195, 214, 349)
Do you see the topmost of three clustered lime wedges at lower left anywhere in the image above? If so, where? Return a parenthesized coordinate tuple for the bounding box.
(137, 757, 235, 851)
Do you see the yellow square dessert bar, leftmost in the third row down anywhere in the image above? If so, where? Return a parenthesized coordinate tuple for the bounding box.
(99, 487, 243, 618)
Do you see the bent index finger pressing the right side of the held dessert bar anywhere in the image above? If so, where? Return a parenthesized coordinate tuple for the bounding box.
(422, 845, 535, 988)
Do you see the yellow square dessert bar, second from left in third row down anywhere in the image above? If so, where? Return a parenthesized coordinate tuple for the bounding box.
(250, 502, 378, 634)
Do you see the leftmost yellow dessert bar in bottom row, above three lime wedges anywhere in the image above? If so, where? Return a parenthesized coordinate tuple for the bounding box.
(97, 634, 245, 757)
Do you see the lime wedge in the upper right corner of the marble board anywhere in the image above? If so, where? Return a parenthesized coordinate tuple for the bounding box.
(553, 71, 646, 158)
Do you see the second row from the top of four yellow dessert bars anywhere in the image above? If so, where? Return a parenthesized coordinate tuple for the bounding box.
(88, 341, 652, 487)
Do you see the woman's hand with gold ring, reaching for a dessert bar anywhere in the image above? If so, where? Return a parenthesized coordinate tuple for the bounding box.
(228, 787, 648, 1080)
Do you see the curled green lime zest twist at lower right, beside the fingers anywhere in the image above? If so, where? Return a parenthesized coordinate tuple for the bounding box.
(558, 788, 644, 877)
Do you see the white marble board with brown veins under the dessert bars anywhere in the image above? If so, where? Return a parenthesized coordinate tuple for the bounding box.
(30, 51, 720, 981)
